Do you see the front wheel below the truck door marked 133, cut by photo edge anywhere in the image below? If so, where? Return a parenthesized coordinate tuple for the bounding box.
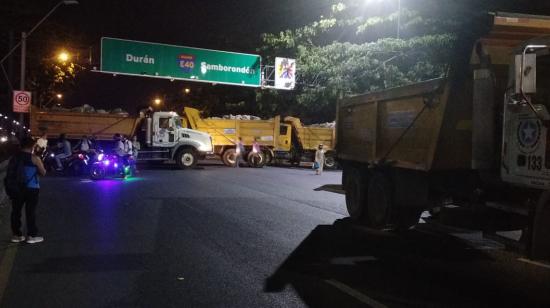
(530, 192, 550, 261)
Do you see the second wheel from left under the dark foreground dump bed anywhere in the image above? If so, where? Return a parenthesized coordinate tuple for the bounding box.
(367, 173, 393, 229)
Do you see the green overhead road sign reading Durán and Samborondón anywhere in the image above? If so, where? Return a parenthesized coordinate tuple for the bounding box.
(100, 37, 261, 87)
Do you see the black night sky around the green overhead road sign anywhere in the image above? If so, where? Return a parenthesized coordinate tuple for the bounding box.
(0, 0, 545, 112)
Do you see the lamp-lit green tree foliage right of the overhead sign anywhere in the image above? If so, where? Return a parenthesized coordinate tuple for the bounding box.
(257, 1, 458, 121)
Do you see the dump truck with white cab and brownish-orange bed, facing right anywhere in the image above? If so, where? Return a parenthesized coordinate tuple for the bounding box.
(30, 107, 213, 169)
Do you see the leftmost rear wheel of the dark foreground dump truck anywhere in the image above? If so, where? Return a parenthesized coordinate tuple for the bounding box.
(344, 167, 368, 221)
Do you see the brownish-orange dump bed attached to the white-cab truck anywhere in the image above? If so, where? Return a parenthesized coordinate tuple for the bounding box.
(30, 108, 139, 140)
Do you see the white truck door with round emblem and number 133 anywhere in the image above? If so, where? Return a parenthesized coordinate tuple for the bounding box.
(501, 49, 550, 188)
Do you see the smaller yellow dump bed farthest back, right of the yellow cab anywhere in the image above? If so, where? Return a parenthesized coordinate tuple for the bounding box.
(285, 117, 334, 151)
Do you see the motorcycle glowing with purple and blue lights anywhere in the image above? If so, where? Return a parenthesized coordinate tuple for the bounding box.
(90, 153, 133, 180)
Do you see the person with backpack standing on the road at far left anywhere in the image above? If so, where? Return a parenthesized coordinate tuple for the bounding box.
(4, 137, 46, 244)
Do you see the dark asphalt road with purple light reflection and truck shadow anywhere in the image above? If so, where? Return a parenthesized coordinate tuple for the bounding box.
(0, 165, 550, 307)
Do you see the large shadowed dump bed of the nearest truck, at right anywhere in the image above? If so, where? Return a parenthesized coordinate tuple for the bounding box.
(336, 78, 471, 171)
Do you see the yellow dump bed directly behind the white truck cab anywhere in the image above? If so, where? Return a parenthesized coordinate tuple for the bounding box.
(184, 107, 280, 147)
